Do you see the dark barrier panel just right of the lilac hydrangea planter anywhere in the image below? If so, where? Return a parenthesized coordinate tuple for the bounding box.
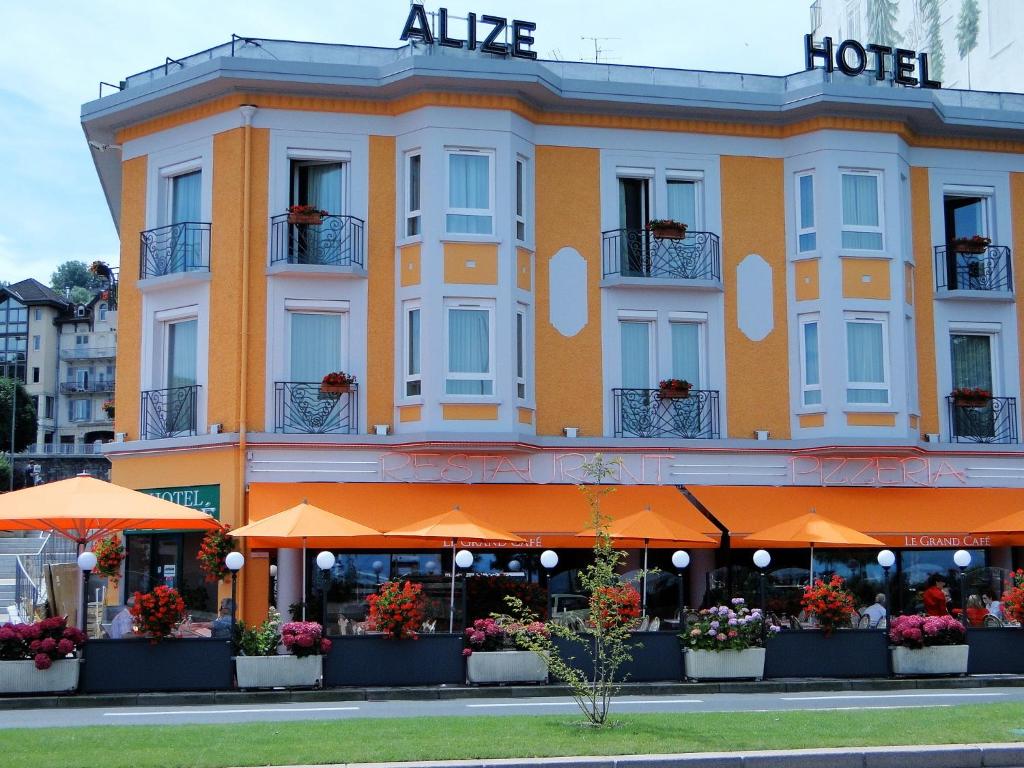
(765, 630, 889, 678)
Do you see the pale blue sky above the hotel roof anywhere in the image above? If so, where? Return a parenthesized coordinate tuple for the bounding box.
(0, 0, 810, 283)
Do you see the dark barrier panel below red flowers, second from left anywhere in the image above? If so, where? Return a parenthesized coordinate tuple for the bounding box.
(324, 634, 466, 688)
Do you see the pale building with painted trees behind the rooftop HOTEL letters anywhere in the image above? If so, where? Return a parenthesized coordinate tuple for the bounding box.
(811, 0, 1024, 92)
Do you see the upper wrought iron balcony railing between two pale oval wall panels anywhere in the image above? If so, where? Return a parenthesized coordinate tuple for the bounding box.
(601, 229, 722, 281)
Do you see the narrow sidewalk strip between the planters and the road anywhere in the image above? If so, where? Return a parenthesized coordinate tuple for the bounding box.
(6, 675, 1024, 712)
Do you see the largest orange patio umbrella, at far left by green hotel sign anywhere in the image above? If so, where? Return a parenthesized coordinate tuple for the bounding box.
(0, 475, 220, 549)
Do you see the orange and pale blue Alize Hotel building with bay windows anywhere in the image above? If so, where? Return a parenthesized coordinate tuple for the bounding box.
(82, 30, 1024, 617)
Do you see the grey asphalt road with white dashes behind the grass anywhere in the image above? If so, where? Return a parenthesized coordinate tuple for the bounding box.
(0, 688, 1024, 729)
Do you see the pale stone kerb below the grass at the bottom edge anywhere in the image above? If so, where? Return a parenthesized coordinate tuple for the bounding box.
(237, 743, 1024, 768)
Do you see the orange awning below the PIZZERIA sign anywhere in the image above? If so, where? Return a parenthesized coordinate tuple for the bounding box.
(688, 485, 1024, 548)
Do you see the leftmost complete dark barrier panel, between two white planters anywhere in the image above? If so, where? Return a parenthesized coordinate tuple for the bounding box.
(82, 637, 234, 693)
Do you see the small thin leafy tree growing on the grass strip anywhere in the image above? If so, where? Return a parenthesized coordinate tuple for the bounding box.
(496, 454, 639, 726)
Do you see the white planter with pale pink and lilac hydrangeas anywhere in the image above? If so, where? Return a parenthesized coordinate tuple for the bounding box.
(680, 597, 779, 680)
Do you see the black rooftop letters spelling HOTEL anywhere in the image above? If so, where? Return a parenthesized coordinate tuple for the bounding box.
(804, 35, 942, 88)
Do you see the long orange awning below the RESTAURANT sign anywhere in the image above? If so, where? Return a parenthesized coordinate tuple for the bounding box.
(249, 482, 718, 550)
